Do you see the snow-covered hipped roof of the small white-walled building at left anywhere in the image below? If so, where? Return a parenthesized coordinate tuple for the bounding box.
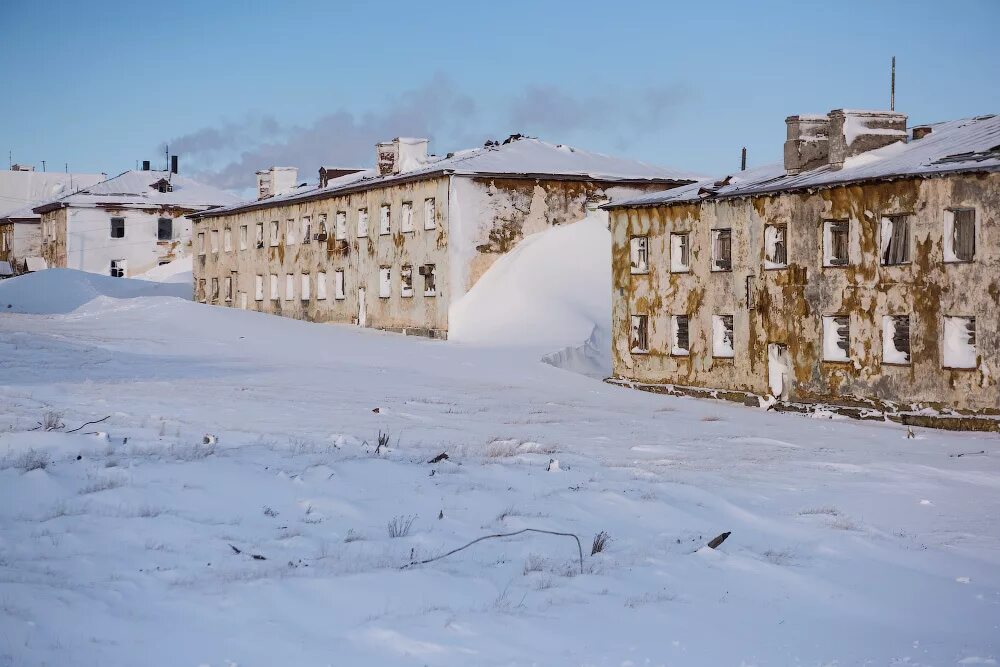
(33, 171, 239, 213)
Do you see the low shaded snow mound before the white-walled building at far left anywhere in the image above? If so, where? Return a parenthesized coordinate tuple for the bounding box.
(0, 269, 191, 315)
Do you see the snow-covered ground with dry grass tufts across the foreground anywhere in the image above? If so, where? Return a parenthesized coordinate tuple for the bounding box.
(0, 271, 1000, 666)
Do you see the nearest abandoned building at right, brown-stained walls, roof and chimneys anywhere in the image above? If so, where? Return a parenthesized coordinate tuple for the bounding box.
(606, 110, 1000, 413)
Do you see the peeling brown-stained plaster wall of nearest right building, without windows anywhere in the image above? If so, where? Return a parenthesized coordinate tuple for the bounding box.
(612, 173, 1000, 411)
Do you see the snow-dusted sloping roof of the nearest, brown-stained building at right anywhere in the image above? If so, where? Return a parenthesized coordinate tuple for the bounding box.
(605, 114, 1000, 209)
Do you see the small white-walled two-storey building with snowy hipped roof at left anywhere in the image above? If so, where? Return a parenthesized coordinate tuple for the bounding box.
(32, 164, 239, 277)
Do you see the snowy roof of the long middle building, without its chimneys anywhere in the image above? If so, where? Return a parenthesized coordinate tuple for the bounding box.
(196, 135, 700, 217)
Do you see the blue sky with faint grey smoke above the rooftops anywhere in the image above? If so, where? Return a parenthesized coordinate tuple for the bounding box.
(0, 0, 1000, 188)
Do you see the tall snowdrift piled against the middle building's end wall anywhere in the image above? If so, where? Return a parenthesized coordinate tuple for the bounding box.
(448, 213, 611, 375)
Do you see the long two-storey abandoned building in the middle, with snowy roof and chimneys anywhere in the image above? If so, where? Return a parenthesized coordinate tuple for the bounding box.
(192, 135, 693, 338)
